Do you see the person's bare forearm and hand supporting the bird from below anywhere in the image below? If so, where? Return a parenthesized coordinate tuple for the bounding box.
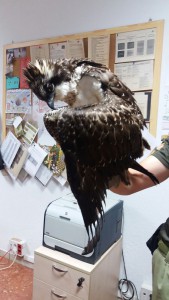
(109, 155, 169, 195)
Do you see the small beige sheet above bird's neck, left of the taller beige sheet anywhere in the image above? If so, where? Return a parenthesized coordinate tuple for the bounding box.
(67, 39, 85, 58)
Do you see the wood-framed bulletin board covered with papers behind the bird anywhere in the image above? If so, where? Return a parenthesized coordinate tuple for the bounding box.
(2, 20, 164, 142)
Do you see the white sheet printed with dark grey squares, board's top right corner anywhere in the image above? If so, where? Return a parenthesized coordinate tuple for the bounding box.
(115, 28, 156, 63)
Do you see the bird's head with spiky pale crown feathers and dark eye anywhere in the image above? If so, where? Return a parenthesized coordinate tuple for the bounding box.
(23, 59, 69, 109)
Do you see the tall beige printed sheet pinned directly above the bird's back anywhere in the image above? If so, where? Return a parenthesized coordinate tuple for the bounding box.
(88, 35, 110, 66)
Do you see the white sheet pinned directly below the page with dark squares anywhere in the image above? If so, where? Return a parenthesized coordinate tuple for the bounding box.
(114, 60, 154, 91)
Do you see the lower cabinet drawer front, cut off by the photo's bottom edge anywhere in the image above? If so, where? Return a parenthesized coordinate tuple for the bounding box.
(32, 279, 83, 300)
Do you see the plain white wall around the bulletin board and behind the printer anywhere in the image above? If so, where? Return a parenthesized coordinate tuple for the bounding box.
(0, 0, 169, 292)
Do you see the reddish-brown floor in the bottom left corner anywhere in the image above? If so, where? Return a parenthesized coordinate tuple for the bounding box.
(0, 258, 33, 300)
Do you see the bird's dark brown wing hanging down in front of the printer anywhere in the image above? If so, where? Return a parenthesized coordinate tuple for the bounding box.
(44, 95, 158, 253)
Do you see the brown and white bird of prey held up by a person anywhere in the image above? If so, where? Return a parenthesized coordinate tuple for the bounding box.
(24, 58, 158, 254)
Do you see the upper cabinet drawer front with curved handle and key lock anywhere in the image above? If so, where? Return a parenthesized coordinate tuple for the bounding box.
(34, 255, 89, 299)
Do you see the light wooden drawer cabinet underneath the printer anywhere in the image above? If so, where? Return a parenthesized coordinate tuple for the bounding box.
(33, 238, 122, 300)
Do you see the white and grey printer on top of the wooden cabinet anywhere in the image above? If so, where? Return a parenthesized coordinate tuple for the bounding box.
(43, 190, 123, 264)
